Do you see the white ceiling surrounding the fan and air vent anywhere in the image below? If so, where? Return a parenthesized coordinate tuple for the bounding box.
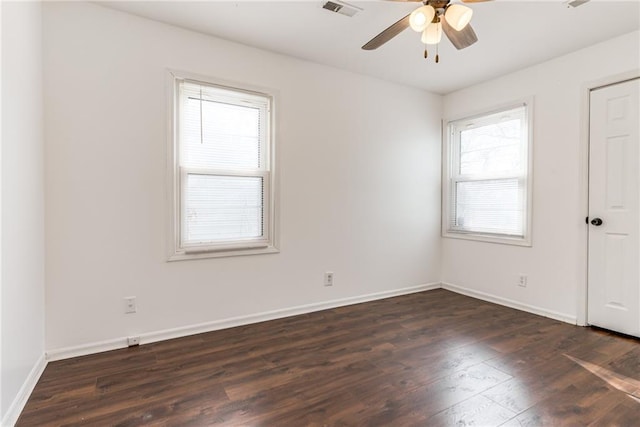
(100, 0, 640, 94)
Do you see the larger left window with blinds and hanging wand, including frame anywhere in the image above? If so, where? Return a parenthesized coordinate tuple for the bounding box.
(169, 72, 277, 260)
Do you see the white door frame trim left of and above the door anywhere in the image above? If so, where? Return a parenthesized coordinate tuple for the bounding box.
(576, 69, 640, 326)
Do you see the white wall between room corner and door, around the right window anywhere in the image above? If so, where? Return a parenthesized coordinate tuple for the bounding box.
(442, 31, 640, 320)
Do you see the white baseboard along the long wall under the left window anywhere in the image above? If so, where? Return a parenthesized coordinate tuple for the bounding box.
(46, 282, 441, 361)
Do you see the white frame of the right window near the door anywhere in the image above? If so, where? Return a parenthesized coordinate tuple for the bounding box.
(441, 97, 534, 247)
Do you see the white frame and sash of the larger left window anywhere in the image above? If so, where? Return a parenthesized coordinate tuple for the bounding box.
(167, 70, 279, 261)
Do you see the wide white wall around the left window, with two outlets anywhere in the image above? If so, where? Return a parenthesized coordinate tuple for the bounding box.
(44, 3, 441, 350)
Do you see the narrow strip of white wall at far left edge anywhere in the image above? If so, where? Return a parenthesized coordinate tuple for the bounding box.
(0, 2, 44, 425)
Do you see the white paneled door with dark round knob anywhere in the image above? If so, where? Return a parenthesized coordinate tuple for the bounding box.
(588, 79, 640, 336)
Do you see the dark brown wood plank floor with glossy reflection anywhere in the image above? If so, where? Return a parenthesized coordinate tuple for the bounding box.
(18, 290, 640, 426)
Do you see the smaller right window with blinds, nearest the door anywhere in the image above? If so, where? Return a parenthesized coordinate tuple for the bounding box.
(442, 104, 531, 245)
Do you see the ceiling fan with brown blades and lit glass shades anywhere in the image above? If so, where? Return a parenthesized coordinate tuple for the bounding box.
(362, 0, 490, 62)
